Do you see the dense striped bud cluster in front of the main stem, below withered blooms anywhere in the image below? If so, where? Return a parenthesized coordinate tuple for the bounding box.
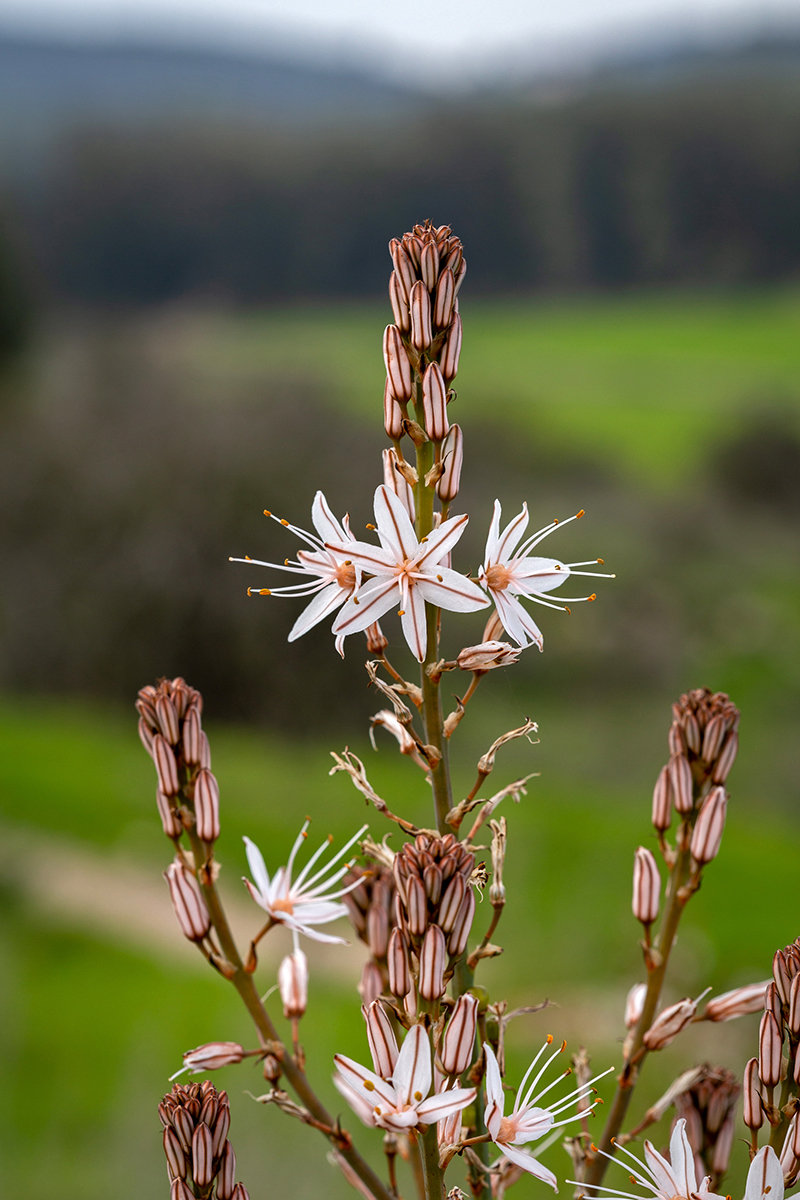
(387, 834, 475, 1001)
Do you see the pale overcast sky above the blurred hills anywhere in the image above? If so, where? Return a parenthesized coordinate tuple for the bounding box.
(0, 0, 800, 79)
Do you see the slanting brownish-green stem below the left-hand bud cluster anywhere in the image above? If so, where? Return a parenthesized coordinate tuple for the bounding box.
(190, 830, 391, 1200)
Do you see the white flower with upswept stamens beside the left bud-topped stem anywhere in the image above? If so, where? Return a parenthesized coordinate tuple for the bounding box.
(245, 821, 367, 946)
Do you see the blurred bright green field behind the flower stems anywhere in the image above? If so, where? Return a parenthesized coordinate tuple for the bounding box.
(0, 289, 800, 1200)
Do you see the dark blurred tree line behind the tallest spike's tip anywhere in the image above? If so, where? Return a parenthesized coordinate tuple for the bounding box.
(7, 74, 800, 305)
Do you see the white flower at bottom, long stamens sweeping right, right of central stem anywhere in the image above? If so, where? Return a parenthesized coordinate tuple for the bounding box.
(483, 1038, 613, 1192)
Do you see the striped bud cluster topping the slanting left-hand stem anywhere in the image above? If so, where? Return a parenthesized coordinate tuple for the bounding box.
(136, 677, 219, 848)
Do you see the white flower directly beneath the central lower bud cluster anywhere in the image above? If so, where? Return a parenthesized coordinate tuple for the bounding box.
(333, 1025, 476, 1133)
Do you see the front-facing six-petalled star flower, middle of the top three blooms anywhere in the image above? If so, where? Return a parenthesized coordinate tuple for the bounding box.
(326, 485, 488, 662)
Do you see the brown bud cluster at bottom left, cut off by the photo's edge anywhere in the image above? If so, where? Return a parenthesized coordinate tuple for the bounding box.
(158, 1080, 249, 1200)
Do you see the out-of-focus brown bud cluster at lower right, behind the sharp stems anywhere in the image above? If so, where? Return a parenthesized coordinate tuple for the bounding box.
(673, 1063, 741, 1187)
